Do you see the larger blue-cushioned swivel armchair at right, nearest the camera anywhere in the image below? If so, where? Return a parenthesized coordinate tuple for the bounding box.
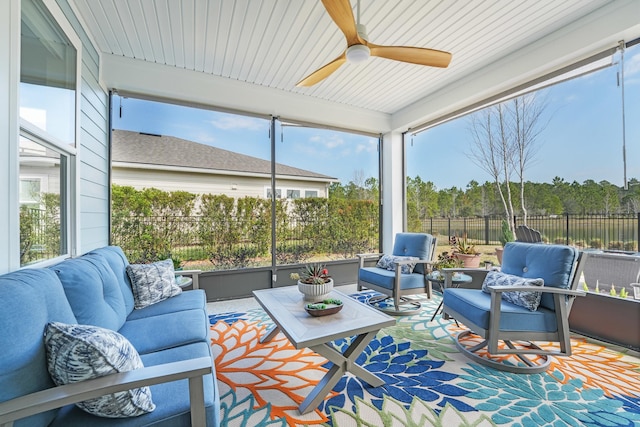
(443, 242, 588, 373)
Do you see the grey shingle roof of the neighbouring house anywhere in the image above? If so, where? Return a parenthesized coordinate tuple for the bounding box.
(112, 129, 337, 181)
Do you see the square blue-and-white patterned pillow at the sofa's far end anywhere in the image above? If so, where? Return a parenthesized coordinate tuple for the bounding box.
(127, 259, 182, 308)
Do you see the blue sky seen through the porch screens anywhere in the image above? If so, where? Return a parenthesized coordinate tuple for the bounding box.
(114, 45, 640, 189)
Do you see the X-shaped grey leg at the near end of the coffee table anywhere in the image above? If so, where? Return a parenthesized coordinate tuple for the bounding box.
(298, 331, 384, 414)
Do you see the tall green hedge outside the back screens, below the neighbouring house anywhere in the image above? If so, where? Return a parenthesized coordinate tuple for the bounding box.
(112, 185, 379, 269)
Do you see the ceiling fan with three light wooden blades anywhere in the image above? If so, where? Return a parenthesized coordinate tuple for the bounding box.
(296, 0, 451, 87)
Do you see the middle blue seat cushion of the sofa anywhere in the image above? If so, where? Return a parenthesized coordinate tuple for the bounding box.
(118, 310, 209, 354)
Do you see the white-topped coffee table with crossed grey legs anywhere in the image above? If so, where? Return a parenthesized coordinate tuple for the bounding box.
(253, 286, 396, 414)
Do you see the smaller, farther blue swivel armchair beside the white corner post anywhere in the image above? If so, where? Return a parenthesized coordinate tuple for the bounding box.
(358, 233, 437, 316)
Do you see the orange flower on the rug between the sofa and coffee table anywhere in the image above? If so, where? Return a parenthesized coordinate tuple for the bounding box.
(210, 320, 336, 425)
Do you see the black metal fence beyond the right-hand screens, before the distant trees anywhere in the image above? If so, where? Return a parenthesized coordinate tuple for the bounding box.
(412, 213, 640, 252)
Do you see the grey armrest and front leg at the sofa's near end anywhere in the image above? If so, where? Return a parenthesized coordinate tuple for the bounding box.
(0, 357, 212, 427)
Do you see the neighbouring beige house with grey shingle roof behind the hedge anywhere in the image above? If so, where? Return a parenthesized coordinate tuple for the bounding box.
(111, 130, 338, 199)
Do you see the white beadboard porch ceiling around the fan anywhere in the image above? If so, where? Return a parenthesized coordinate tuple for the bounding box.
(70, 0, 610, 118)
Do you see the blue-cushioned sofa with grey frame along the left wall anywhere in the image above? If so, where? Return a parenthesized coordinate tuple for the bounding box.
(0, 246, 220, 427)
